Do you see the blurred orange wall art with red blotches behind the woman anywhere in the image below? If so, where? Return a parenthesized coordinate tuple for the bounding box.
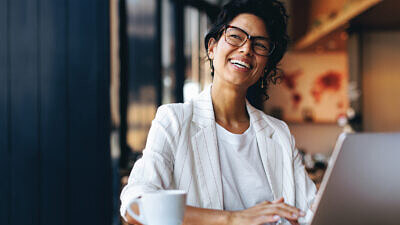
(265, 52, 349, 123)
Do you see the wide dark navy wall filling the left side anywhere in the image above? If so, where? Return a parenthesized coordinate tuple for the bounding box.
(0, 0, 112, 225)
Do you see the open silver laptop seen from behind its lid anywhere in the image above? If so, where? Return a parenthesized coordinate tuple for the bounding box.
(311, 133, 400, 225)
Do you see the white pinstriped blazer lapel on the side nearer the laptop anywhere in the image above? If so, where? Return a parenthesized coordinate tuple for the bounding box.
(247, 103, 283, 199)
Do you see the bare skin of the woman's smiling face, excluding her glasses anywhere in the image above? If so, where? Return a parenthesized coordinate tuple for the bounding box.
(208, 13, 268, 90)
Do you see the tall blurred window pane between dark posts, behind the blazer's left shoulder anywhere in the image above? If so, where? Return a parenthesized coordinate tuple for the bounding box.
(120, 0, 162, 157)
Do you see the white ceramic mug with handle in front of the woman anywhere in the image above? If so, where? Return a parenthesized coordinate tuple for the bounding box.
(127, 190, 186, 225)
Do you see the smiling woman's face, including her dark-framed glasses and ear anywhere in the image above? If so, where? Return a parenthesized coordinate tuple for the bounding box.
(208, 13, 269, 99)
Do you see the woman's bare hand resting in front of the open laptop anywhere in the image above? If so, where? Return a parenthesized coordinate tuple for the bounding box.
(229, 198, 305, 225)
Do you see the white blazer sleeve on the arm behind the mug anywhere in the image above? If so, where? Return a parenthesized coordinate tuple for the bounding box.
(120, 106, 179, 220)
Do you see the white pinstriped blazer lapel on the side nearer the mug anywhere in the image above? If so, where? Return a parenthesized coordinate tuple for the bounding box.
(191, 86, 223, 209)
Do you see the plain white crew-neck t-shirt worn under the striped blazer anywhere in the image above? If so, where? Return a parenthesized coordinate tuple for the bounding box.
(216, 123, 273, 210)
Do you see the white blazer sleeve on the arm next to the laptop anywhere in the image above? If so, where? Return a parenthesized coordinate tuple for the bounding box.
(291, 136, 317, 223)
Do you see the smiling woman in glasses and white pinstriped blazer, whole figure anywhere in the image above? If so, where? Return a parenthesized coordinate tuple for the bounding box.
(121, 0, 316, 224)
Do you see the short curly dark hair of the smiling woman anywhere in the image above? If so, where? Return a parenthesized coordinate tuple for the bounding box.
(204, 0, 289, 102)
